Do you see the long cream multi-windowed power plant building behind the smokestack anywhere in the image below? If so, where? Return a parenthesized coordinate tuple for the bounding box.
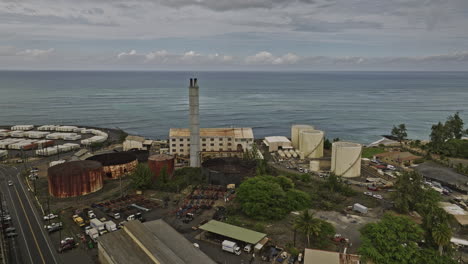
(169, 128, 254, 156)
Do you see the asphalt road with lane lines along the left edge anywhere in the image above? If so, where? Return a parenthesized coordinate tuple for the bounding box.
(0, 165, 61, 264)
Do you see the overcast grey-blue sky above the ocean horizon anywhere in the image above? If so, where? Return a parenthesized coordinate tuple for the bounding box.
(0, 0, 468, 71)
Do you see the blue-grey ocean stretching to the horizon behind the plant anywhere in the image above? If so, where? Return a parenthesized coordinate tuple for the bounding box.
(0, 71, 468, 143)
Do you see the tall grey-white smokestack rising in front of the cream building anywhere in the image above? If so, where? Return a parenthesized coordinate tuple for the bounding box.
(189, 78, 200, 167)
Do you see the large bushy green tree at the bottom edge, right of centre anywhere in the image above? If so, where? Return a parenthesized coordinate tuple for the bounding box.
(358, 214, 424, 264)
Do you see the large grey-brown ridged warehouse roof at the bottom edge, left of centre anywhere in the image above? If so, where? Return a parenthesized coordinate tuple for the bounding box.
(98, 220, 215, 264)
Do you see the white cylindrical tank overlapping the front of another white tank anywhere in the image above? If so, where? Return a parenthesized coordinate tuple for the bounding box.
(299, 129, 325, 159)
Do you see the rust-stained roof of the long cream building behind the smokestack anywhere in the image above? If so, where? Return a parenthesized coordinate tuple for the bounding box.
(169, 127, 253, 139)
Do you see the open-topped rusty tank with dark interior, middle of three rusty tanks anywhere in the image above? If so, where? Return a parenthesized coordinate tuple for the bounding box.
(86, 152, 138, 179)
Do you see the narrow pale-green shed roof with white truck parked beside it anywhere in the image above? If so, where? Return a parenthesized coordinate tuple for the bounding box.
(200, 220, 266, 244)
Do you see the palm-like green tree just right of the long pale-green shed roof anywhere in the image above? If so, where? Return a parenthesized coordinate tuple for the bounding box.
(294, 210, 335, 247)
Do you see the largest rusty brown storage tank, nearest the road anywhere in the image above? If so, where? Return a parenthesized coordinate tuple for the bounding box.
(47, 160, 104, 198)
